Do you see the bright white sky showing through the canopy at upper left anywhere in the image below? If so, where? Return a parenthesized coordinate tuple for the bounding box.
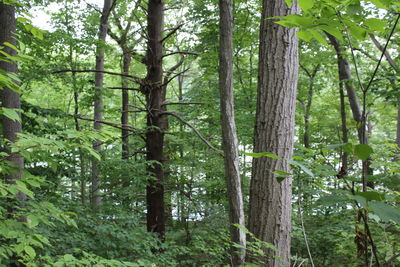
(29, 0, 104, 31)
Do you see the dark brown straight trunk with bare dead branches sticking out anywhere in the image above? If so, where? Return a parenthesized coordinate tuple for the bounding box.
(141, 0, 167, 240)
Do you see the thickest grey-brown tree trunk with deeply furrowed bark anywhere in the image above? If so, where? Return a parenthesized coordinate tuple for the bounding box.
(249, 0, 299, 267)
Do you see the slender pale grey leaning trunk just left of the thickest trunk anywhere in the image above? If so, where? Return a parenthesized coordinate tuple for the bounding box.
(219, 0, 246, 266)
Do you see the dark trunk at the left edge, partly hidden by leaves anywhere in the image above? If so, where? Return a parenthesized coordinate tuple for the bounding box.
(0, 3, 25, 199)
